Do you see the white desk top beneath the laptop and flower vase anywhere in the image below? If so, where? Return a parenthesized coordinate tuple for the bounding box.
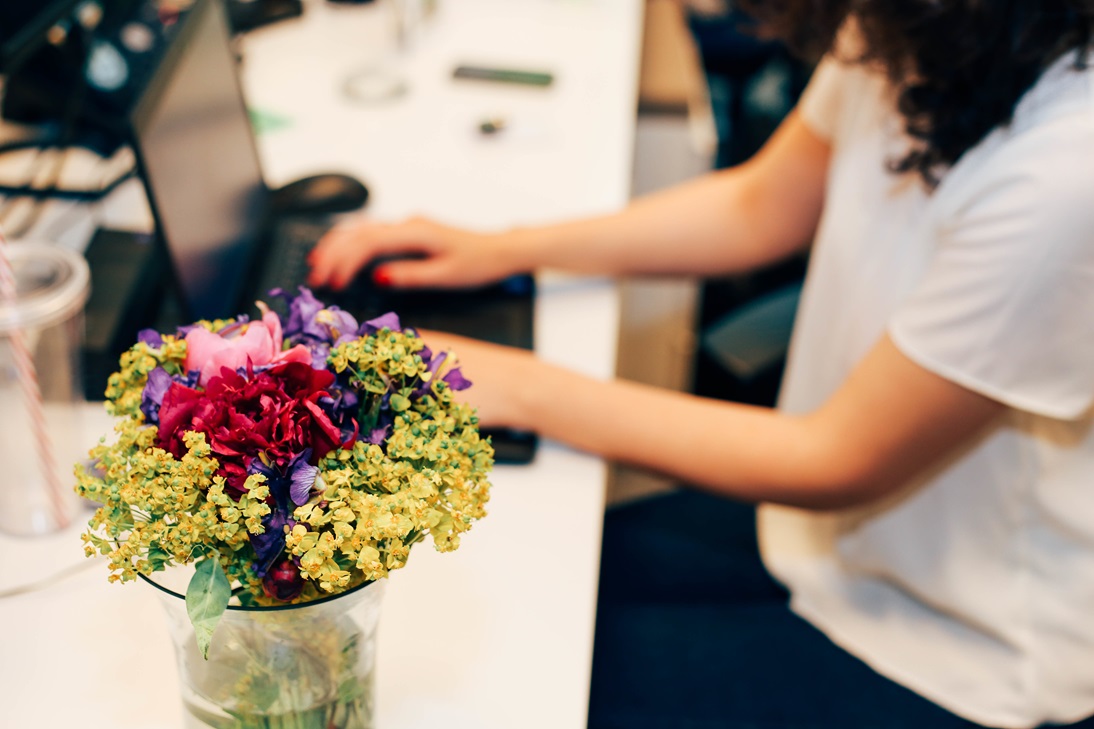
(0, 0, 642, 729)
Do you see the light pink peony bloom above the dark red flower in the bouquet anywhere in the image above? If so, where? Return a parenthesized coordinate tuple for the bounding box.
(186, 304, 312, 387)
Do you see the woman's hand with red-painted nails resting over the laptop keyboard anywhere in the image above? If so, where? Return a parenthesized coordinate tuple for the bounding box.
(307, 218, 531, 289)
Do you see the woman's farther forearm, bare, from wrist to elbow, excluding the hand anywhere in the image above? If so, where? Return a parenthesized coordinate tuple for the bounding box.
(507, 115, 828, 276)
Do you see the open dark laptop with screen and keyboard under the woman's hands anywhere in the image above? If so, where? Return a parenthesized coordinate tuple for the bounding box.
(130, 0, 536, 463)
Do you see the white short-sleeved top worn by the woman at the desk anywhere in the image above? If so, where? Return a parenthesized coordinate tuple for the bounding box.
(760, 49, 1094, 728)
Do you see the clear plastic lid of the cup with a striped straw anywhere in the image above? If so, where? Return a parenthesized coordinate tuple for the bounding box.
(0, 242, 91, 335)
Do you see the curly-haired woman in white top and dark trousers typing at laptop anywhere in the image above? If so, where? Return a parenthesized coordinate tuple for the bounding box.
(312, 0, 1094, 728)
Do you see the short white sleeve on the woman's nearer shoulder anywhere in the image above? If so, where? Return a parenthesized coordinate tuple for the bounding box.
(889, 116, 1094, 419)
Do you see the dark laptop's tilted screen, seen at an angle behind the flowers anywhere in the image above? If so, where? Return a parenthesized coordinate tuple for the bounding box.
(132, 1, 268, 319)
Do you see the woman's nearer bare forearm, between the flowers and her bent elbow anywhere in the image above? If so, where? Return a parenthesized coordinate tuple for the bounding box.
(503, 356, 844, 508)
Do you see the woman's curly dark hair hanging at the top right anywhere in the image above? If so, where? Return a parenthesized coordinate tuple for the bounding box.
(741, 0, 1094, 186)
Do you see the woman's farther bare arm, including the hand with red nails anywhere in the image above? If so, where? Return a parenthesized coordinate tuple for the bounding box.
(309, 113, 828, 288)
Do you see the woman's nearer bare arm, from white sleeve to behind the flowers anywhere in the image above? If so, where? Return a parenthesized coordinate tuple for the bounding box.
(427, 333, 1004, 509)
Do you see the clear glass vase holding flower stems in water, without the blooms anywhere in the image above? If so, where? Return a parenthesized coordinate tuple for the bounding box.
(146, 575, 383, 729)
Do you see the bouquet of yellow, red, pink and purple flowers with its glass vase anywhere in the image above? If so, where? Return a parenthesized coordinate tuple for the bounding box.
(77, 288, 493, 729)
